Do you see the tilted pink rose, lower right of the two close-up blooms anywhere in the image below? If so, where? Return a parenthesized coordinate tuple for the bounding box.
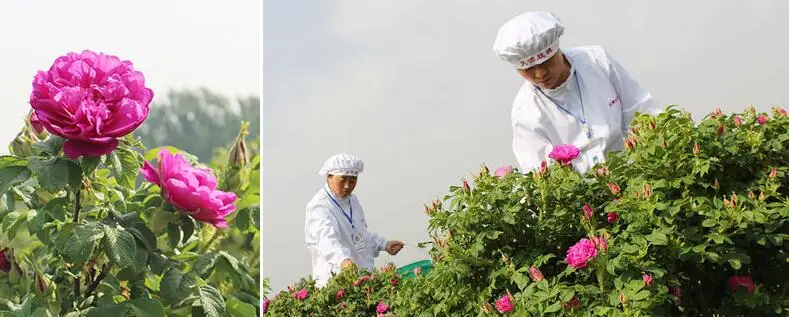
(140, 148, 236, 228)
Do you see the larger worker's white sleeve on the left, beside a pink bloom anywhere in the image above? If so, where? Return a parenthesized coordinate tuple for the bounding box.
(512, 108, 551, 174)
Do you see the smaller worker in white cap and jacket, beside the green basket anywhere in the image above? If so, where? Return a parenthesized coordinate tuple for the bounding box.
(305, 153, 403, 287)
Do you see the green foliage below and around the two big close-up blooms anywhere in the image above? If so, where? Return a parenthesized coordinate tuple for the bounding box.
(0, 122, 260, 317)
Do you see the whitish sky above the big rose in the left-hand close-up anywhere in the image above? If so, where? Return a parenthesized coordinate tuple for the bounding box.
(0, 0, 262, 154)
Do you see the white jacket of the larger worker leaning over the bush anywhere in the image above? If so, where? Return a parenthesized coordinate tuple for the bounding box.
(512, 46, 660, 173)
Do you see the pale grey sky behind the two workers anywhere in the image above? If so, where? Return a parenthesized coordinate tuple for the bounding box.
(263, 0, 789, 290)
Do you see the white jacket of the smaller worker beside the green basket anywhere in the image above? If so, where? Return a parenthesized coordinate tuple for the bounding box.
(304, 185, 387, 287)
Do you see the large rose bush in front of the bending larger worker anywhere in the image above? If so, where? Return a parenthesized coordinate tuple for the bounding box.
(270, 107, 789, 316)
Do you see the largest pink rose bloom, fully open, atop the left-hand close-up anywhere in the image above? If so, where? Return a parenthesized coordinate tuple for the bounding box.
(30, 50, 153, 159)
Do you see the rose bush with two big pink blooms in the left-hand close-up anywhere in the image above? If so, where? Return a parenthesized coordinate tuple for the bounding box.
(0, 51, 260, 317)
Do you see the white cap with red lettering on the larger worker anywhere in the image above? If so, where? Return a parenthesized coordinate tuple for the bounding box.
(493, 11, 564, 69)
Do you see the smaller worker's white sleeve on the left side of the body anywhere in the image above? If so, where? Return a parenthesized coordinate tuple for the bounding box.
(307, 204, 352, 267)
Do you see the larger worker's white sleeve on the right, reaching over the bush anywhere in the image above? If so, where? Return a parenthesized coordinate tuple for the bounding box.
(604, 50, 660, 134)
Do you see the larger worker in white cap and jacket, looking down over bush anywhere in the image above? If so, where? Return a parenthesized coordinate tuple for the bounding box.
(493, 12, 660, 173)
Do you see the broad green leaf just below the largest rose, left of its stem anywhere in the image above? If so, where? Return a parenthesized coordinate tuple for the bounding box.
(28, 157, 82, 193)
